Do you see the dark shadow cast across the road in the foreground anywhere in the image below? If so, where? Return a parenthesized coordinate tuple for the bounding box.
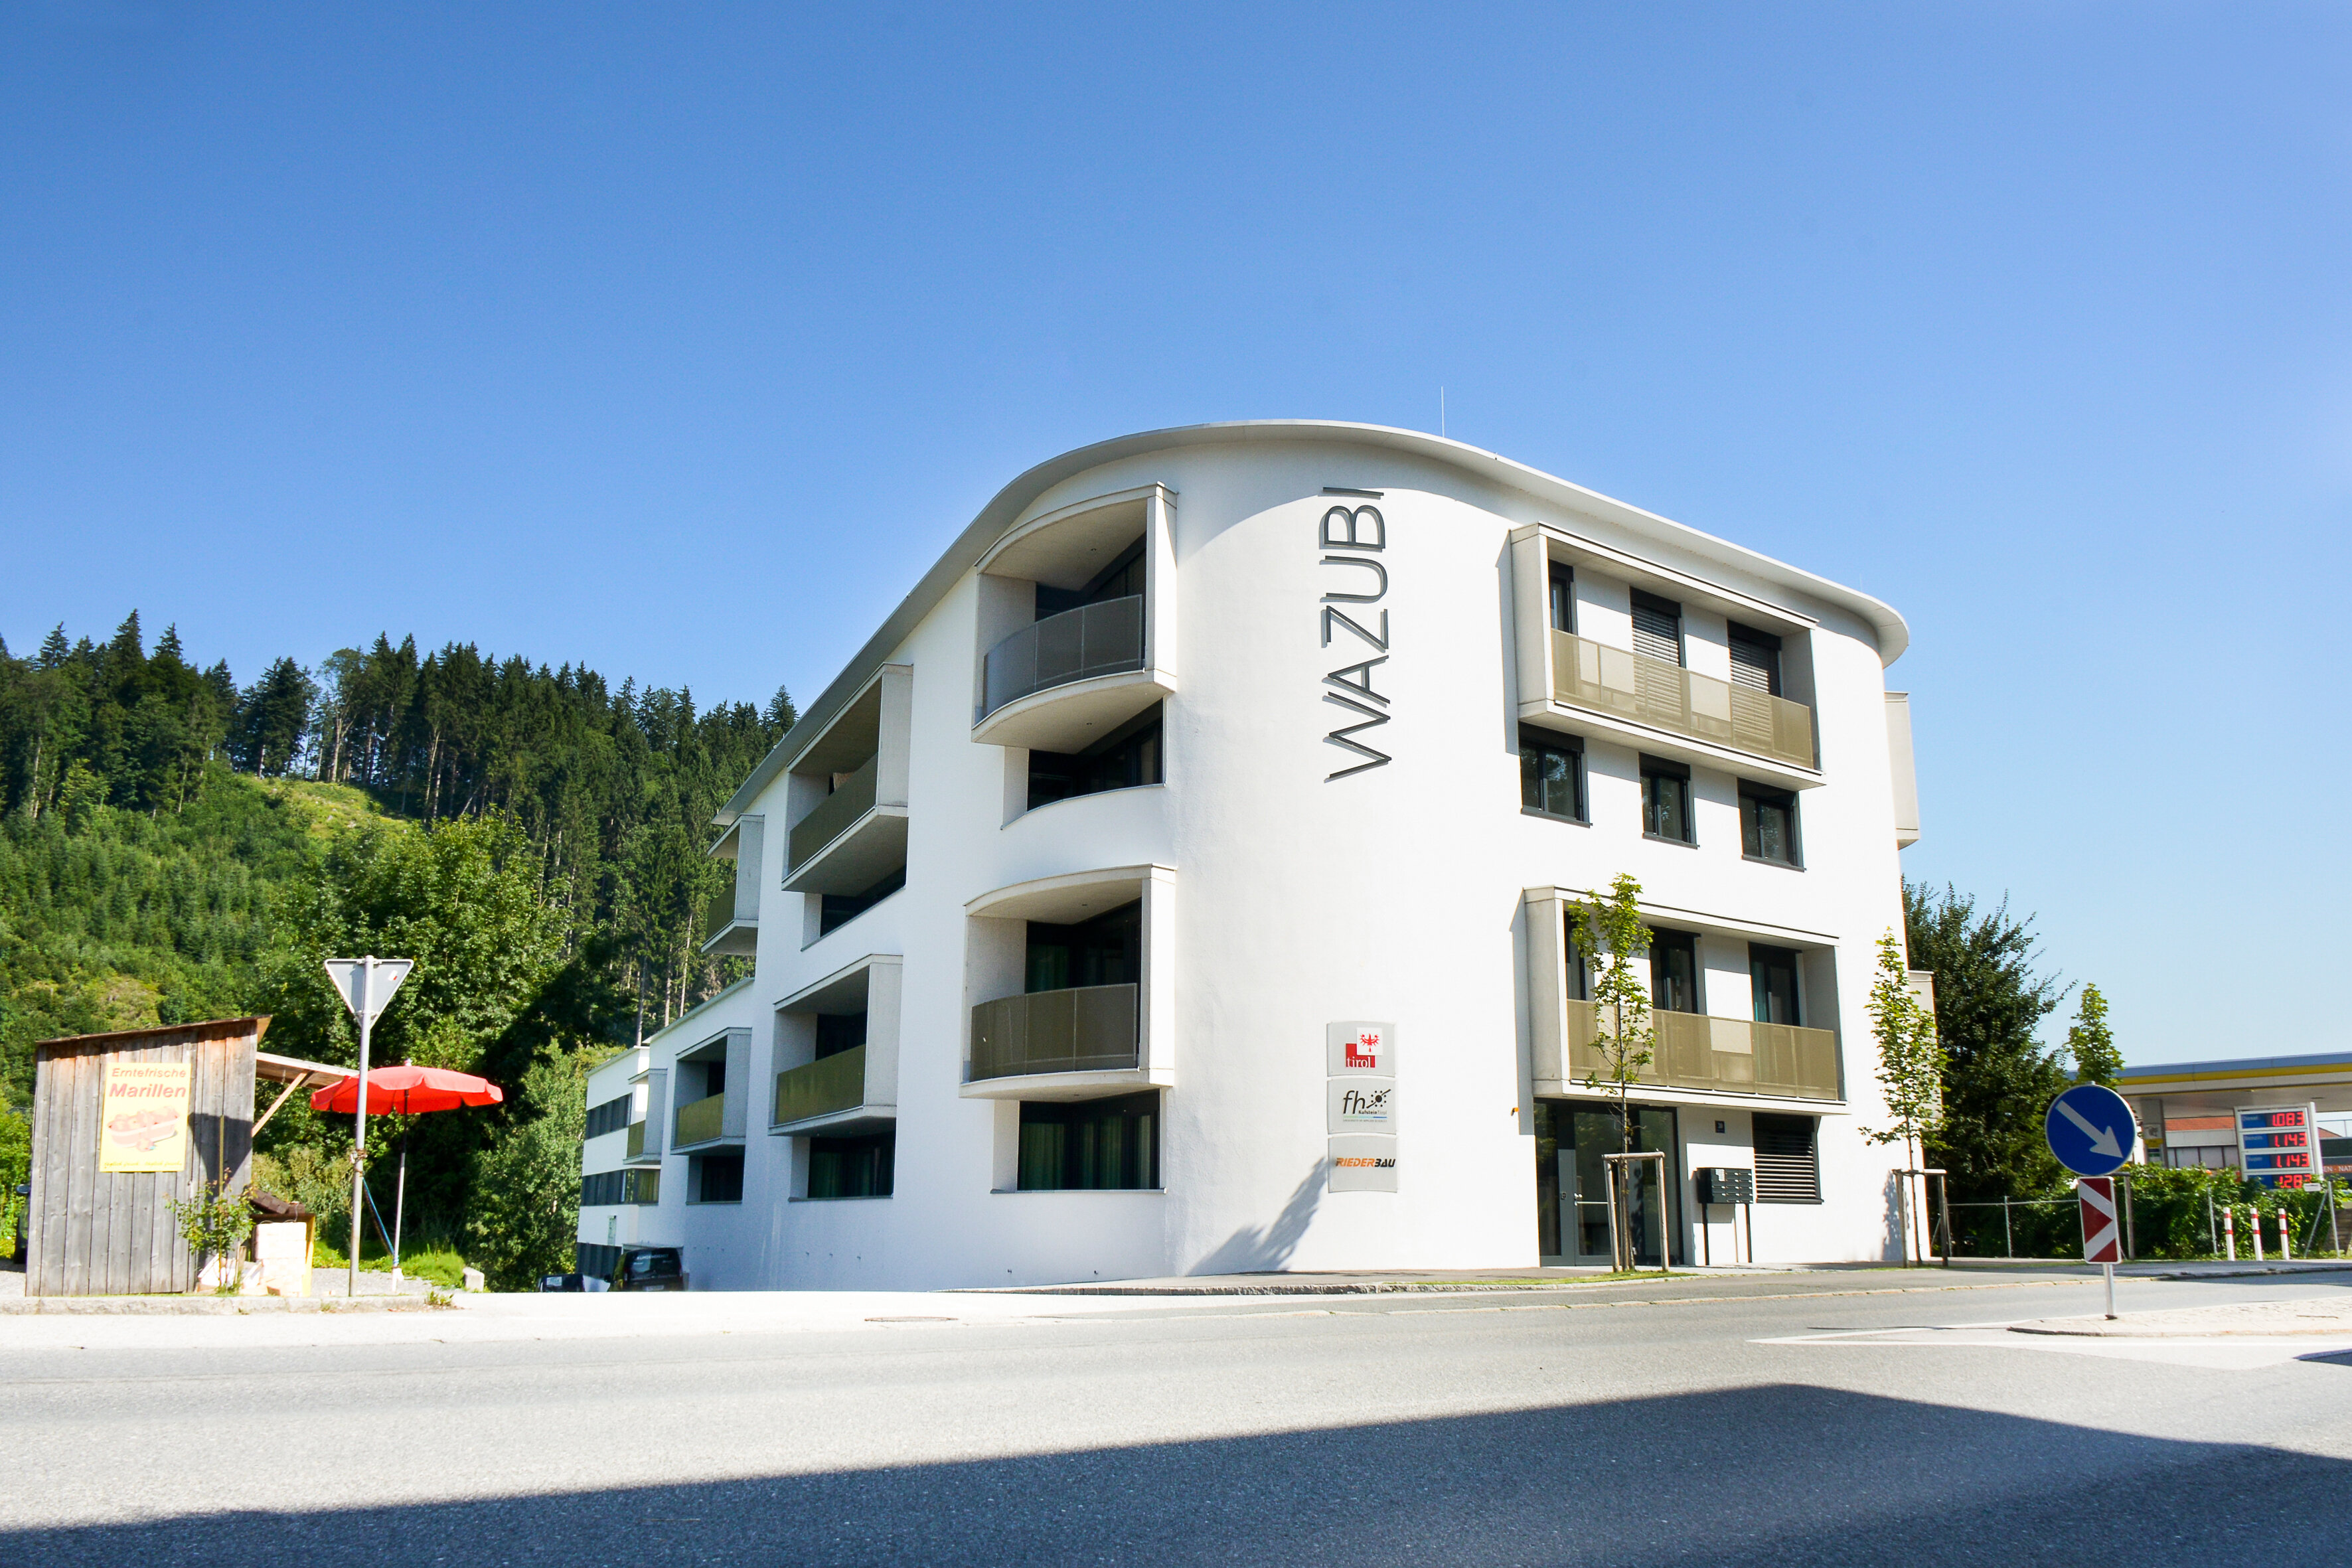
(0, 1361, 2352, 1568)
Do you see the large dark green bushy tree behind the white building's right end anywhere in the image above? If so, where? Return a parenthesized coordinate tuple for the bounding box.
(1903, 884, 2072, 1202)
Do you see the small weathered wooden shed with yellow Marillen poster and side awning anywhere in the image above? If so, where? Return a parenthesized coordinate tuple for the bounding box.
(23, 1018, 351, 1295)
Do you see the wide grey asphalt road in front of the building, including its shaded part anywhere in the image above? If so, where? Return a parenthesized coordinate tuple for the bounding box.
(0, 1274, 2352, 1568)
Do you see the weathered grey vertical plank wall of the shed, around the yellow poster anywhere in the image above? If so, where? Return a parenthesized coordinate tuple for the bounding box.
(23, 1018, 266, 1295)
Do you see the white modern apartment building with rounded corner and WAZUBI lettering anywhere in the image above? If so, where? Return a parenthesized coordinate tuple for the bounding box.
(581, 421, 1917, 1289)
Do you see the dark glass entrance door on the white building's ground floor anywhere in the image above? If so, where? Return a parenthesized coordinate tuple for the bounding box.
(1536, 1100, 1682, 1269)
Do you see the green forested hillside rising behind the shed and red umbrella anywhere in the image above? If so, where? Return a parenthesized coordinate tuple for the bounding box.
(0, 613, 793, 1279)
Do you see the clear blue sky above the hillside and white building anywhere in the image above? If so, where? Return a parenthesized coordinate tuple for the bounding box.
(0, 0, 2352, 1060)
